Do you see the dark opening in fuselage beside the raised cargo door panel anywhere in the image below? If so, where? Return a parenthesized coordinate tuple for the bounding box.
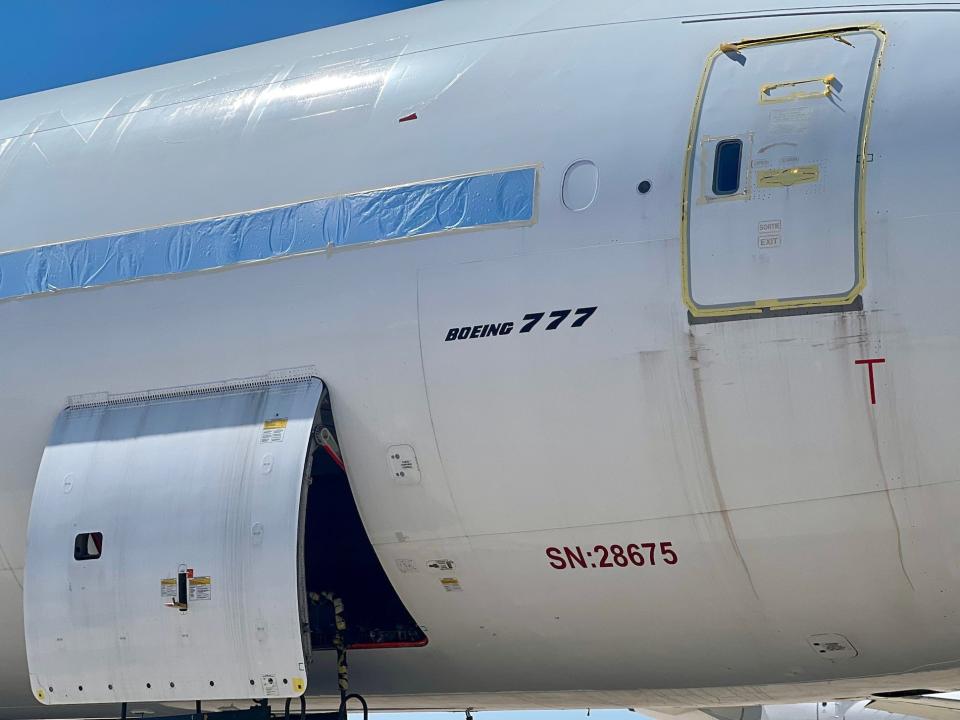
(303, 393, 427, 650)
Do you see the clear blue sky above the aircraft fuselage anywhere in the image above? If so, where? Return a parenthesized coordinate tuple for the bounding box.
(0, 0, 429, 99)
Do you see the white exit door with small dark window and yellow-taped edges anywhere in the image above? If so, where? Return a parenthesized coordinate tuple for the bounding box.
(682, 27, 884, 318)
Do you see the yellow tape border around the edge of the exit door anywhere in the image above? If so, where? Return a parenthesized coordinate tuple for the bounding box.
(680, 23, 887, 318)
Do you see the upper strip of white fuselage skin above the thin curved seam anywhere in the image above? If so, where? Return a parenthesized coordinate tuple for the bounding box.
(0, 0, 930, 137)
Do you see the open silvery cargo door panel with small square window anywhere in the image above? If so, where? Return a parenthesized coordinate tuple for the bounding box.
(24, 374, 323, 704)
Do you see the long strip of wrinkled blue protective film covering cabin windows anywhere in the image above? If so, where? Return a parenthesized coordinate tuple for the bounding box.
(0, 168, 536, 299)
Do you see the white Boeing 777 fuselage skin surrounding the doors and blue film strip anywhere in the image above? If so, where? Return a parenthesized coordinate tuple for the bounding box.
(0, 2, 960, 718)
